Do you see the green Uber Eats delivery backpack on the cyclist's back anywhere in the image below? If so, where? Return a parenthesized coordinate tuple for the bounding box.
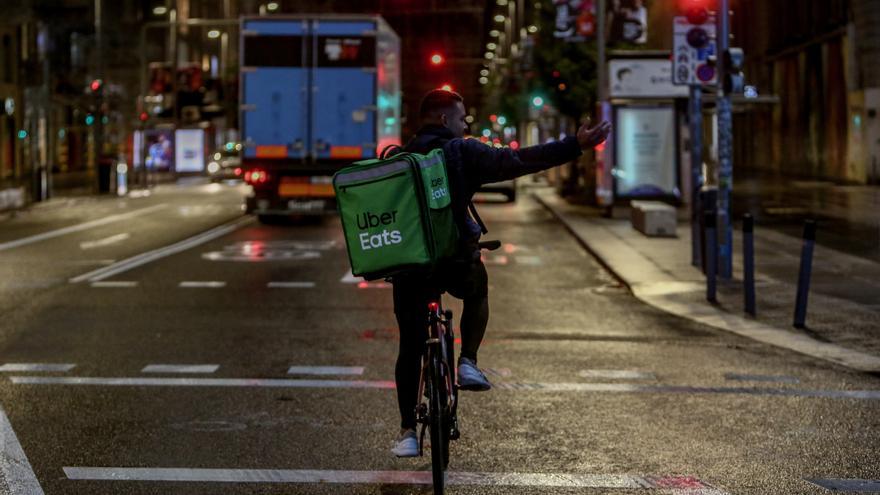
(333, 149, 458, 280)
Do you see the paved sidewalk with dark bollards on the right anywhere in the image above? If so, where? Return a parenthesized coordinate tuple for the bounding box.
(533, 188, 880, 372)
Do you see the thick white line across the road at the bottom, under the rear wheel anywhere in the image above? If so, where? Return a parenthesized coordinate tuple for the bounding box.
(63, 467, 724, 495)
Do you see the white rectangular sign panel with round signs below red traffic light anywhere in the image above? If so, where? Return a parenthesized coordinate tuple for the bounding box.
(672, 16, 716, 85)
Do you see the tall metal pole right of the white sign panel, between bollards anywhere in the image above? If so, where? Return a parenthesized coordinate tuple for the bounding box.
(716, 0, 733, 279)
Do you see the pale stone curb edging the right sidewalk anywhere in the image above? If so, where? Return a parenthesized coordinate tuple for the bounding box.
(531, 193, 880, 373)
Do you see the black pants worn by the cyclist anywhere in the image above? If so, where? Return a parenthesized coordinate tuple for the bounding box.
(393, 260, 489, 428)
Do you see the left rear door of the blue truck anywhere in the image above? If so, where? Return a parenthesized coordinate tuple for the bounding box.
(241, 20, 309, 158)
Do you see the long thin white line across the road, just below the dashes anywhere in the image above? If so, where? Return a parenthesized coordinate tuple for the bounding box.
(9, 376, 880, 400)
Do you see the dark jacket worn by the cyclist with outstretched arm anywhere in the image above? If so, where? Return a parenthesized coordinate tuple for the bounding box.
(404, 125, 581, 252)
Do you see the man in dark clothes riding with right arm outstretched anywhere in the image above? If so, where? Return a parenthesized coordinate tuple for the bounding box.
(392, 89, 611, 457)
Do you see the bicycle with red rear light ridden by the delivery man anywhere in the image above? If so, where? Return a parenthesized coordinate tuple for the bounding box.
(416, 241, 501, 495)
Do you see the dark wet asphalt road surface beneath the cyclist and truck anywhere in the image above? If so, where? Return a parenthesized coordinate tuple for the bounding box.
(0, 185, 880, 494)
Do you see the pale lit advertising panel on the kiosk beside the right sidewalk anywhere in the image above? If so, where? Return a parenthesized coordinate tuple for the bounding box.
(613, 106, 681, 197)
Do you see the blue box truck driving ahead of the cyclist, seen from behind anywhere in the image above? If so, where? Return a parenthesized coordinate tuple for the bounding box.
(239, 15, 401, 220)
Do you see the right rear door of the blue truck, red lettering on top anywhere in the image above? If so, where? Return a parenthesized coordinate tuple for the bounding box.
(312, 20, 377, 160)
